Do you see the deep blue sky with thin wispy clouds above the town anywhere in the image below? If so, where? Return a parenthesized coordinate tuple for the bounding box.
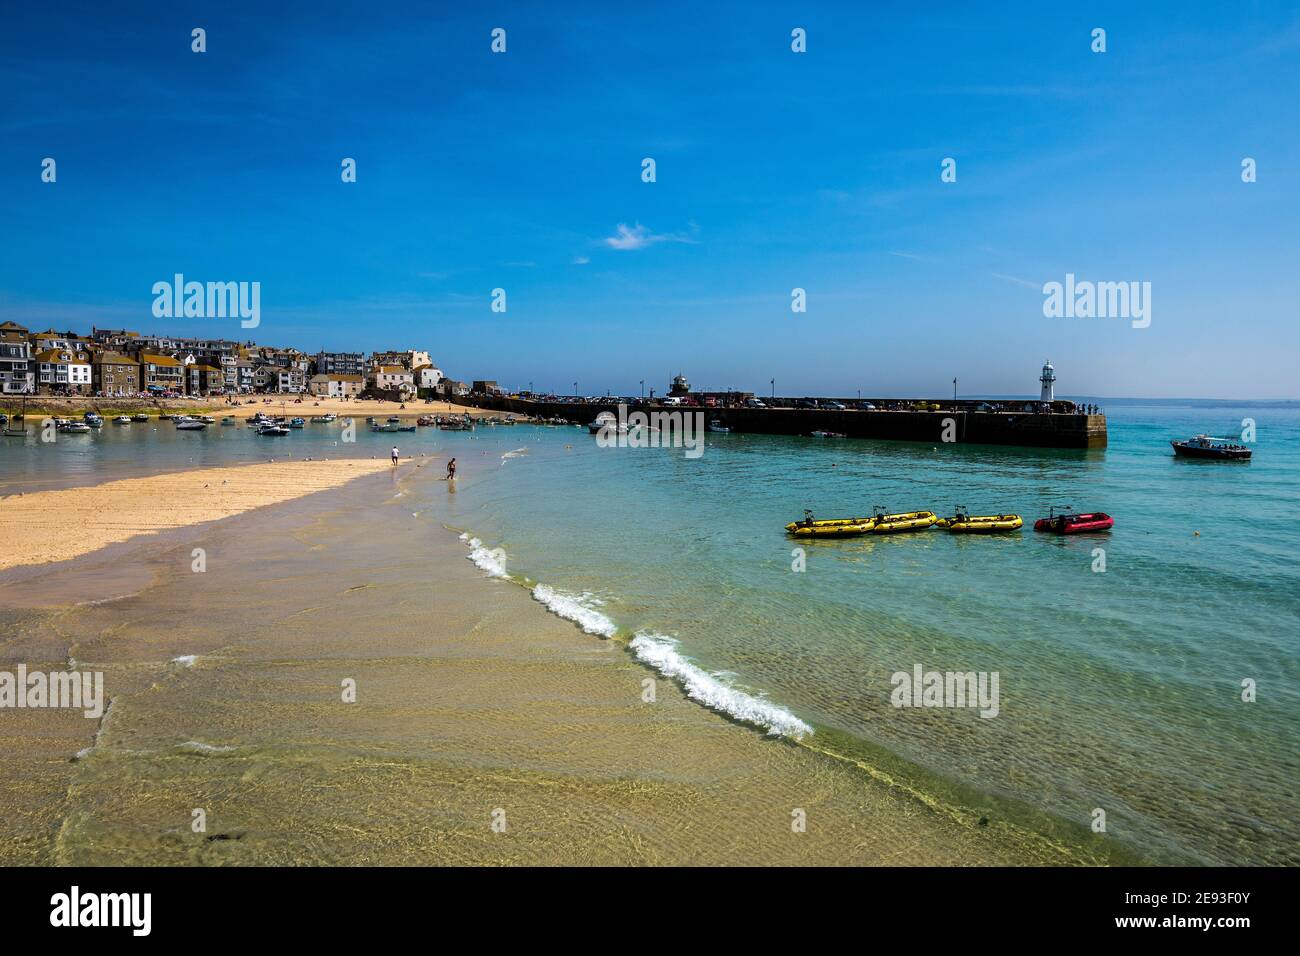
(0, 3, 1300, 398)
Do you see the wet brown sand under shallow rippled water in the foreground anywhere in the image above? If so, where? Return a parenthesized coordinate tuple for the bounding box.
(0, 464, 1063, 865)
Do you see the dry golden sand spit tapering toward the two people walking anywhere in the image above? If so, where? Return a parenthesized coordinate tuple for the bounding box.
(0, 458, 393, 571)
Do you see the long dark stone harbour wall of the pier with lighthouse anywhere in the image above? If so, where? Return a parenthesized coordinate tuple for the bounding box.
(452, 394, 1106, 449)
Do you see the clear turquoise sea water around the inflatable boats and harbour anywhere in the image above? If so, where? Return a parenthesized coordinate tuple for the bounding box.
(0, 401, 1300, 864)
